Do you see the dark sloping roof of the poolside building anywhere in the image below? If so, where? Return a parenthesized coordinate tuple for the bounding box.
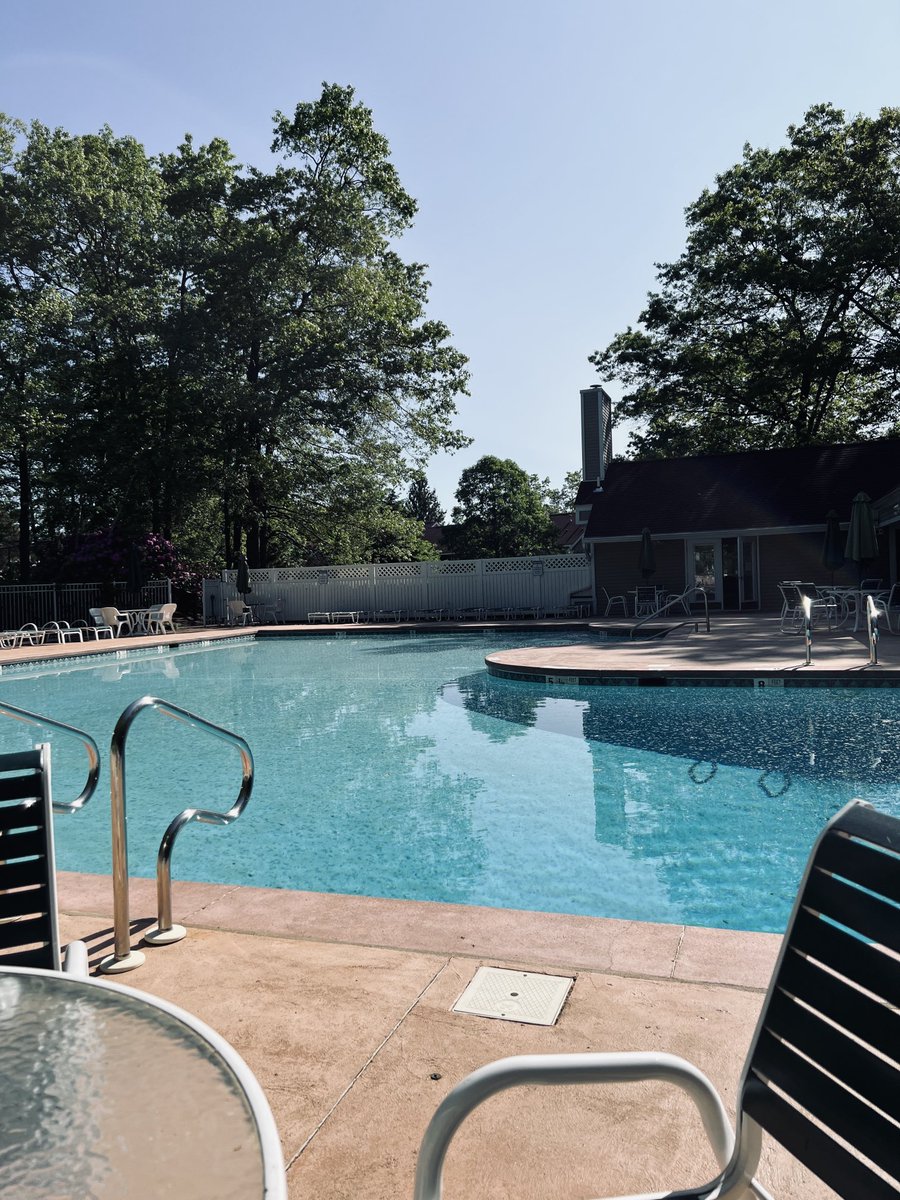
(578, 438, 900, 539)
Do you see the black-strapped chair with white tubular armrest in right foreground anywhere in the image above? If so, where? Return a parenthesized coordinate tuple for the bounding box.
(415, 800, 900, 1200)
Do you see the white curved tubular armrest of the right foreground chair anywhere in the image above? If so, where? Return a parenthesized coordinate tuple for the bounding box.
(414, 1052, 734, 1200)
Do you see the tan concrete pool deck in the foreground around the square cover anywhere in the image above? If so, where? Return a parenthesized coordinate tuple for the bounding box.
(60, 872, 830, 1200)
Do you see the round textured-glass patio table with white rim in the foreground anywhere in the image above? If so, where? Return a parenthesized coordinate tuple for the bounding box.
(0, 967, 287, 1200)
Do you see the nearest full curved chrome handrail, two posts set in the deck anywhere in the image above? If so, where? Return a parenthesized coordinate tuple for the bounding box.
(100, 696, 253, 973)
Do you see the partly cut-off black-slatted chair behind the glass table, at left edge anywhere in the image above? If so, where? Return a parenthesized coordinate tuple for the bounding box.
(0, 745, 88, 974)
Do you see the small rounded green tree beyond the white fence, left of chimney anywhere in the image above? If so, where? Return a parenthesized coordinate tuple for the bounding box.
(450, 455, 557, 558)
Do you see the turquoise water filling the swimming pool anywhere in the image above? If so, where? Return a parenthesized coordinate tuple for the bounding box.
(0, 631, 900, 930)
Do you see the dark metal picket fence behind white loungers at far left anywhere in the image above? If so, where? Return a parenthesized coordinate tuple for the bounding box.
(0, 580, 172, 629)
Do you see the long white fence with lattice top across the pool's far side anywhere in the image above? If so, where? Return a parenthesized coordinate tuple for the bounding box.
(203, 554, 592, 623)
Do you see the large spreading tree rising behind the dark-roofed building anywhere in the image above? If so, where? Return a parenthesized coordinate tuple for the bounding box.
(590, 104, 900, 456)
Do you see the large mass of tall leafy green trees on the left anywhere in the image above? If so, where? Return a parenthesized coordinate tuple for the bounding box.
(0, 84, 468, 578)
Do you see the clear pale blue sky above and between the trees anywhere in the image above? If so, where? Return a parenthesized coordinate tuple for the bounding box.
(0, 0, 900, 508)
